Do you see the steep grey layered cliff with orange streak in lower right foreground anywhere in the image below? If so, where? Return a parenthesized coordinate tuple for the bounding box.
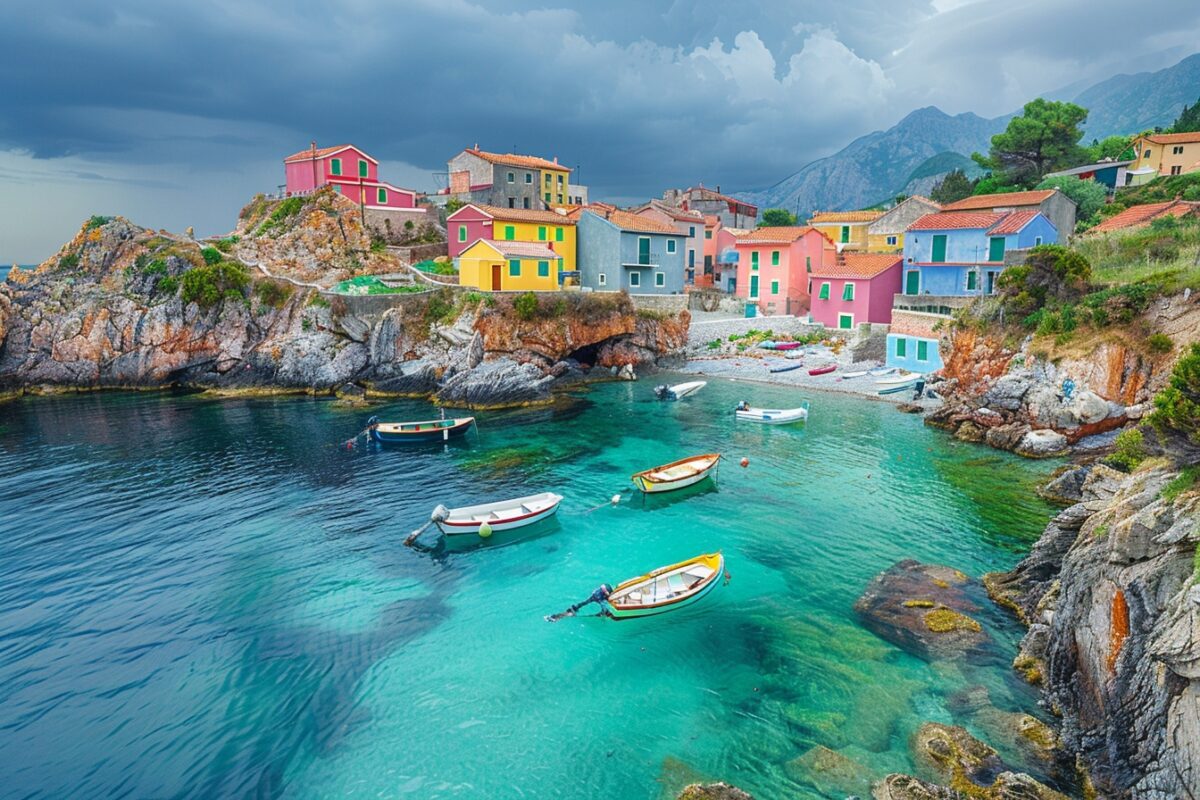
(985, 465, 1200, 800)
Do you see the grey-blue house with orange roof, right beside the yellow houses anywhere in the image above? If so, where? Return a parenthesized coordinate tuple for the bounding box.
(576, 205, 688, 294)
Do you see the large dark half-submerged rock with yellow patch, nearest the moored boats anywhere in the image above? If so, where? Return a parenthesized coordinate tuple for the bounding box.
(854, 559, 990, 658)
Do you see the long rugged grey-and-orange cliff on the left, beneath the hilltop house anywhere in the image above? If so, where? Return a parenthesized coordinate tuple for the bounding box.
(0, 193, 689, 405)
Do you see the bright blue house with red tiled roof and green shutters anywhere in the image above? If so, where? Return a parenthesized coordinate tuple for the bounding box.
(904, 210, 1058, 297)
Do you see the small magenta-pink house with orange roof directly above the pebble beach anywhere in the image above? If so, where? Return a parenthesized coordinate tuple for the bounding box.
(809, 252, 904, 330)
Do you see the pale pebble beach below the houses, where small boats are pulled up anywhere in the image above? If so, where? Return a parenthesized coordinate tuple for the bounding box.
(680, 348, 942, 411)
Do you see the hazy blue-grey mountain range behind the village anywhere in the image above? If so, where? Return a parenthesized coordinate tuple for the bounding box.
(734, 53, 1200, 216)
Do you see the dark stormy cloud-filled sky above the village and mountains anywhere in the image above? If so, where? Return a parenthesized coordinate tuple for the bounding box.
(0, 0, 1200, 263)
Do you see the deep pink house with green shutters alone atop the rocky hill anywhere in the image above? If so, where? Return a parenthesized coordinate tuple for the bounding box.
(283, 142, 420, 211)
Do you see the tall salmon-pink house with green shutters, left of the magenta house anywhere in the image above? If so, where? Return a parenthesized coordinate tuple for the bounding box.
(734, 225, 838, 314)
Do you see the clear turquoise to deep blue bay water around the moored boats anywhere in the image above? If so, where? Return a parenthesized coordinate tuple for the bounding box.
(0, 381, 1051, 799)
